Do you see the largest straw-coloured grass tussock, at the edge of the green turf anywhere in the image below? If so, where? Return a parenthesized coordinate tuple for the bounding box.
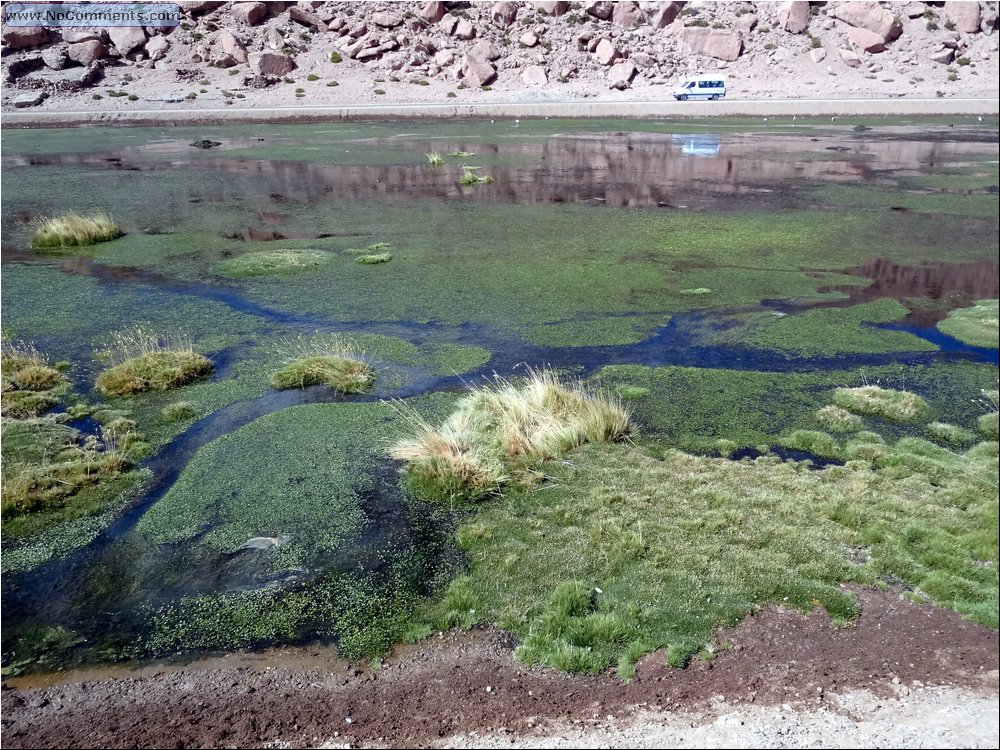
(390, 370, 632, 500)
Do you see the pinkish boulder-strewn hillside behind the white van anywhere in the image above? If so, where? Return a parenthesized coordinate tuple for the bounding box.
(2, 0, 998, 110)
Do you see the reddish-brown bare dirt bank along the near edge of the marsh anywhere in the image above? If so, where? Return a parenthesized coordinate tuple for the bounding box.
(2, 591, 1000, 748)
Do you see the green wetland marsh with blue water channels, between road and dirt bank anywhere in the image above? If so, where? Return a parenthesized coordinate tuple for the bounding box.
(2, 118, 1000, 677)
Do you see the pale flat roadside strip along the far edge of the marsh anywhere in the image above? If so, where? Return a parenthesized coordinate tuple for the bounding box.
(2, 98, 1000, 127)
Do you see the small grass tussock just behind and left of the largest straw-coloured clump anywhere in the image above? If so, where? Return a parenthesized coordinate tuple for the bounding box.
(271, 335, 375, 393)
